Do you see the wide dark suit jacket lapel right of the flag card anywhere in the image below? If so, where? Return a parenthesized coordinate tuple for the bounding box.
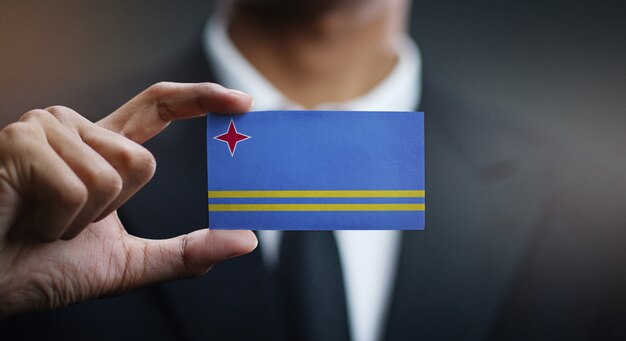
(385, 81, 540, 340)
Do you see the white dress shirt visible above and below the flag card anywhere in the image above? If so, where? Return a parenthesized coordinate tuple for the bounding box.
(203, 11, 421, 341)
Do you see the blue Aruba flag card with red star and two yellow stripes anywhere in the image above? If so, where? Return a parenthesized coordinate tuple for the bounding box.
(207, 110, 425, 230)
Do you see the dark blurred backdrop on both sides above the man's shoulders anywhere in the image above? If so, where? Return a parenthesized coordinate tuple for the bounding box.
(0, 0, 626, 155)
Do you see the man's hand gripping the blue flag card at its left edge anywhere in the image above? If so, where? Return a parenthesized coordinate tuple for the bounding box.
(0, 83, 257, 316)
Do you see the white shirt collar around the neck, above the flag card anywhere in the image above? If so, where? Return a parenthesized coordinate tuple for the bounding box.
(203, 11, 422, 111)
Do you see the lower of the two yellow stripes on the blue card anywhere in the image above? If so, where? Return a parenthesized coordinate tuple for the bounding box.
(209, 204, 426, 212)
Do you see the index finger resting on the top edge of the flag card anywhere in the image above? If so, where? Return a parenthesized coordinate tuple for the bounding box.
(97, 82, 252, 143)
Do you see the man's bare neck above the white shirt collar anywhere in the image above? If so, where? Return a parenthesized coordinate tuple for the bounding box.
(228, 1, 404, 108)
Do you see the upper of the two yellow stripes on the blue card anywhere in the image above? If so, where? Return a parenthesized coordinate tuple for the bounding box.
(209, 190, 426, 199)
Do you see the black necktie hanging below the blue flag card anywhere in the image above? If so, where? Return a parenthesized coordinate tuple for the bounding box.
(278, 231, 350, 341)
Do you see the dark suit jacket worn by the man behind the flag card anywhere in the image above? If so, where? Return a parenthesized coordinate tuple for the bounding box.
(0, 37, 626, 340)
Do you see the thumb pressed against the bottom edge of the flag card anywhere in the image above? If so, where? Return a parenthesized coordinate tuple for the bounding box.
(122, 229, 258, 289)
